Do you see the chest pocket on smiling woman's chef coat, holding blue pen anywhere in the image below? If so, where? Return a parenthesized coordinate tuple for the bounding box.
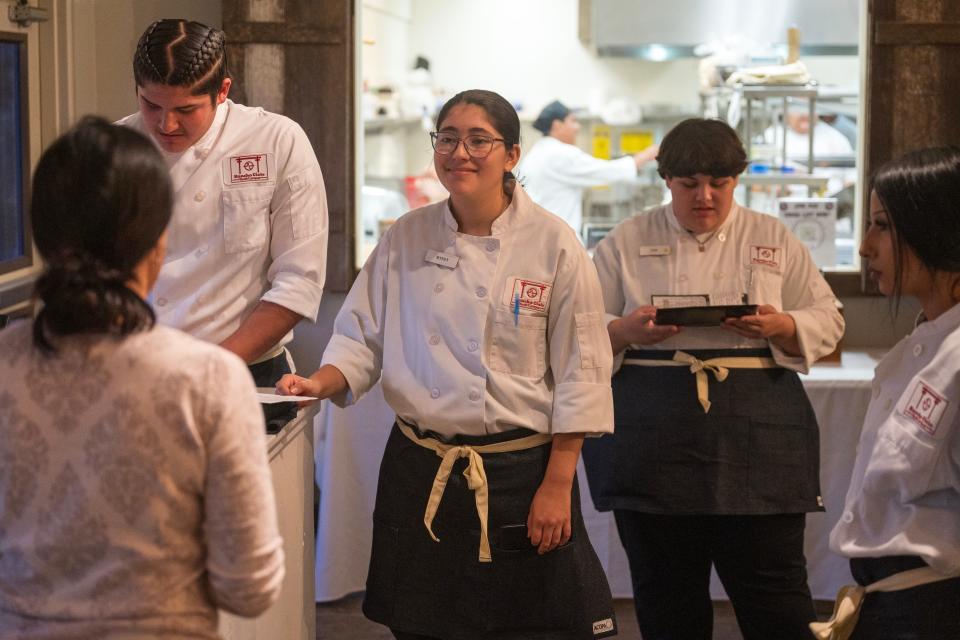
(488, 309, 547, 378)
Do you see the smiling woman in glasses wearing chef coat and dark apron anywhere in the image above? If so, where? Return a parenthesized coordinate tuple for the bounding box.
(278, 90, 616, 640)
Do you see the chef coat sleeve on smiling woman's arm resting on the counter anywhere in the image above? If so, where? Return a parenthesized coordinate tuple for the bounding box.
(321, 230, 392, 407)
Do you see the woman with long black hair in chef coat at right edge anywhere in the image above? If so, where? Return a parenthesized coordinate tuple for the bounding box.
(818, 147, 960, 640)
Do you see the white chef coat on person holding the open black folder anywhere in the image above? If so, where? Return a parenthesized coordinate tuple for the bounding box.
(594, 202, 844, 373)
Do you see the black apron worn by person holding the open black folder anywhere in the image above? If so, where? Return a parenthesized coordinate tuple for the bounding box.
(583, 349, 823, 515)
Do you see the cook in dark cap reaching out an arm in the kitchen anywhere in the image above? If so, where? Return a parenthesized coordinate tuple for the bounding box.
(517, 101, 657, 234)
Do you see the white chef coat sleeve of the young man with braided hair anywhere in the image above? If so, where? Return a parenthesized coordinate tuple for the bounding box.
(261, 123, 329, 321)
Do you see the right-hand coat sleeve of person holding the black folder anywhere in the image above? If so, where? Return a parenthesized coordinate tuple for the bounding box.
(770, 235, 844, 373)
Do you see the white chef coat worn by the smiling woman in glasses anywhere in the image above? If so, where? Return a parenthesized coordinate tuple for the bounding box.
(323, 186, 613, 435)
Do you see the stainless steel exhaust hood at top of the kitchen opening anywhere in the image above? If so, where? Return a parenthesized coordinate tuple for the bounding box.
(579, 0, 862, 60)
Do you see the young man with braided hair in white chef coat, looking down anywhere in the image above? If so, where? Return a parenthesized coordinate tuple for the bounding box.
(120, 19, 327, 427)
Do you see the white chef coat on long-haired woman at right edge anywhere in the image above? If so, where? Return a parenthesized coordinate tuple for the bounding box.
(830, 305, 960, 574)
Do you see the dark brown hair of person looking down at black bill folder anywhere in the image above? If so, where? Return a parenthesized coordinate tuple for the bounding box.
(657, 118, 747, 179)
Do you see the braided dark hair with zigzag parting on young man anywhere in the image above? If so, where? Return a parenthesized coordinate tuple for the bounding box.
(133, 18, 230, 100)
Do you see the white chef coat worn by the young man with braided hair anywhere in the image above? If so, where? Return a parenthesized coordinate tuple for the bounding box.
(119, 100, 327, 345)
